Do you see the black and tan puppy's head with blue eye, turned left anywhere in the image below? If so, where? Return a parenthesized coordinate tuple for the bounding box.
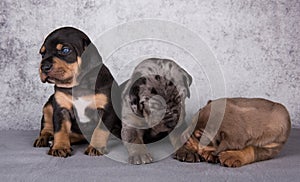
(39, 27, 90, 88)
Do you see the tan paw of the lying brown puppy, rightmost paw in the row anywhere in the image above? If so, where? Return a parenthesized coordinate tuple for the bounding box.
(219, 151, 242, 167)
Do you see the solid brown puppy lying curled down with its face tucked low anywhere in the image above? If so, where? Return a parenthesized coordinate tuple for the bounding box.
(173, 98, 291, 167)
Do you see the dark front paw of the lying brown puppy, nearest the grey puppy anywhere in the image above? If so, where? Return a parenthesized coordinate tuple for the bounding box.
(173, 146, 202, 162)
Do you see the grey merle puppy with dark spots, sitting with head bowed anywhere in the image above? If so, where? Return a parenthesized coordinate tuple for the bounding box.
(121, 58, 192, 164)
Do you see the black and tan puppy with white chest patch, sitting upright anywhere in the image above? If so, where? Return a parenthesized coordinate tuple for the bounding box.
(34, 27, 121, 157)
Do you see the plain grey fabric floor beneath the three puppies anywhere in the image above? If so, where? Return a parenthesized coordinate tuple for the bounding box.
(0, 129, 300, 182)
